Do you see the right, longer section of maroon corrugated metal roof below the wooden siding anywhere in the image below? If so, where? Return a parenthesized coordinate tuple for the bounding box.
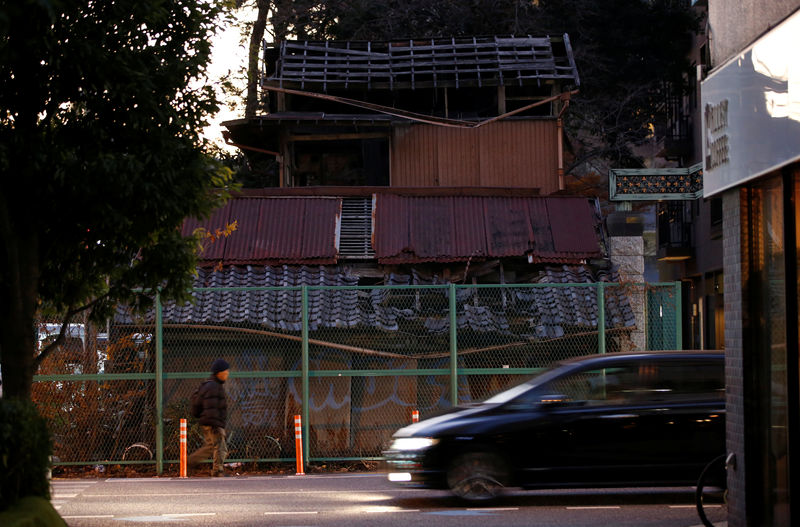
(373, 194, 602, 264)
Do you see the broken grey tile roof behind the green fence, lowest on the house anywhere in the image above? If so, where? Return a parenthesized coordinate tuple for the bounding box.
(116, 265, 636, 340)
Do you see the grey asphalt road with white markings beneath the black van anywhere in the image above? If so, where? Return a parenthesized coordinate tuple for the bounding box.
(52, 473, 725, 527)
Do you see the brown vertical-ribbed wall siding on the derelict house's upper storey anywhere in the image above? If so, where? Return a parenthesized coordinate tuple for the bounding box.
(390, 119, 558, 195)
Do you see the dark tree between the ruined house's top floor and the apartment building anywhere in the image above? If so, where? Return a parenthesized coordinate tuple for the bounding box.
(538, 0, 699, 176)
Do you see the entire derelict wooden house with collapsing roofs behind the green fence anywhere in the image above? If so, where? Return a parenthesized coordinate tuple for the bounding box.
(111, 35, 636, 462)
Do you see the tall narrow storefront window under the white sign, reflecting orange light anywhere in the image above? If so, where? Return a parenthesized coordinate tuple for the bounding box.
(748, 176, 796, 525)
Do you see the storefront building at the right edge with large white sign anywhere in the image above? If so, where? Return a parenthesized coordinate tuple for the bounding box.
(701, 0, 800, 527)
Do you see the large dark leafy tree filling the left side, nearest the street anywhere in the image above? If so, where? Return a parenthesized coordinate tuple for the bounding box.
(0, 0, 230, 399)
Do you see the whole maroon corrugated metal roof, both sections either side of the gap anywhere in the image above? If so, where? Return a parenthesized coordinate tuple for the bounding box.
(183, 189, 602, 265)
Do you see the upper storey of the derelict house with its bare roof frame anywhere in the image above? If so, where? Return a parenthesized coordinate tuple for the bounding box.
(224, 35, 579, 194)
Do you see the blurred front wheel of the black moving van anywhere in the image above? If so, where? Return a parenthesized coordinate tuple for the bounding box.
(447, 452, 508, 501)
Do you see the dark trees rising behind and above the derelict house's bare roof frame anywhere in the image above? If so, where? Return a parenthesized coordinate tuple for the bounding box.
(234, 0, 698, 176)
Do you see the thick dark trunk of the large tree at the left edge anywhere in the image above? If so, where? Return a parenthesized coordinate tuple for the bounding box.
(0, 10, 46, 399)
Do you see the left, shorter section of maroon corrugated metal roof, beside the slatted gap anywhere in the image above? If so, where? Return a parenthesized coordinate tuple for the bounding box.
(183, 197, 341, 265)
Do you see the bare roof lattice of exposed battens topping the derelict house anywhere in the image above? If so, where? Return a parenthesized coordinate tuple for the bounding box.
(263, 34, 580, 91)
